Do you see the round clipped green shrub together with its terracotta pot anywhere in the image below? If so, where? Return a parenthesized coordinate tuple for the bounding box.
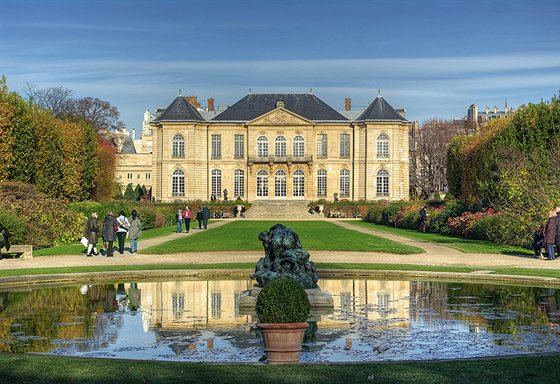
(256, 276, 310, 364)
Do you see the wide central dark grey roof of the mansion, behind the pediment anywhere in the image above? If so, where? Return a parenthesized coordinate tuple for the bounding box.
(212, 93, 348, 121)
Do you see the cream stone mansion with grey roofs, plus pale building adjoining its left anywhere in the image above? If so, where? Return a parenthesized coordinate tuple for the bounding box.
(116, 93, 411, 202)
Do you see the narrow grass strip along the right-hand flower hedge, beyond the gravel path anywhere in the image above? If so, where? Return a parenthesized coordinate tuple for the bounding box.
(346, 220, 533, 255)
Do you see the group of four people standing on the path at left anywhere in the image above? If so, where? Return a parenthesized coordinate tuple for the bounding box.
(84, 209, 142, 257)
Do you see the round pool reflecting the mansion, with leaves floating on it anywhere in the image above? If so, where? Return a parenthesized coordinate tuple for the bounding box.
(0, 279, 560, 362)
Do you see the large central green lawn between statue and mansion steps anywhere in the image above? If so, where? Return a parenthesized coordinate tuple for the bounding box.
(142, 221, 425, 254)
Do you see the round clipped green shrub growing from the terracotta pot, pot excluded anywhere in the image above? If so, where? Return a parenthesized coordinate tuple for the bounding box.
(256, 277, 311, 323)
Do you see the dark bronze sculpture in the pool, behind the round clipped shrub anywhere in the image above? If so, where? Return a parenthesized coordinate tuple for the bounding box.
(251, 224, 319, 289)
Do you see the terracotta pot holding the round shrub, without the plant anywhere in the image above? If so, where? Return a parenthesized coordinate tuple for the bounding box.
(257, 323, 308, 364)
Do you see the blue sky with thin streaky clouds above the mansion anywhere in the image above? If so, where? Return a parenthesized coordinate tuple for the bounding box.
(0, 0, 560, 129)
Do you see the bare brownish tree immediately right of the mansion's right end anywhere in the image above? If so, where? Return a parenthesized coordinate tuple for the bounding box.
(410, 119, 467, 196)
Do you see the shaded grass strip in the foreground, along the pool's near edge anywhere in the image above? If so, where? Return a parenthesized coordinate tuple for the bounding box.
(0, 353, 560, 384)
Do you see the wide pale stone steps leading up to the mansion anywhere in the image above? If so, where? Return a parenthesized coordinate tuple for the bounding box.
(245, 200, 317, 220)
